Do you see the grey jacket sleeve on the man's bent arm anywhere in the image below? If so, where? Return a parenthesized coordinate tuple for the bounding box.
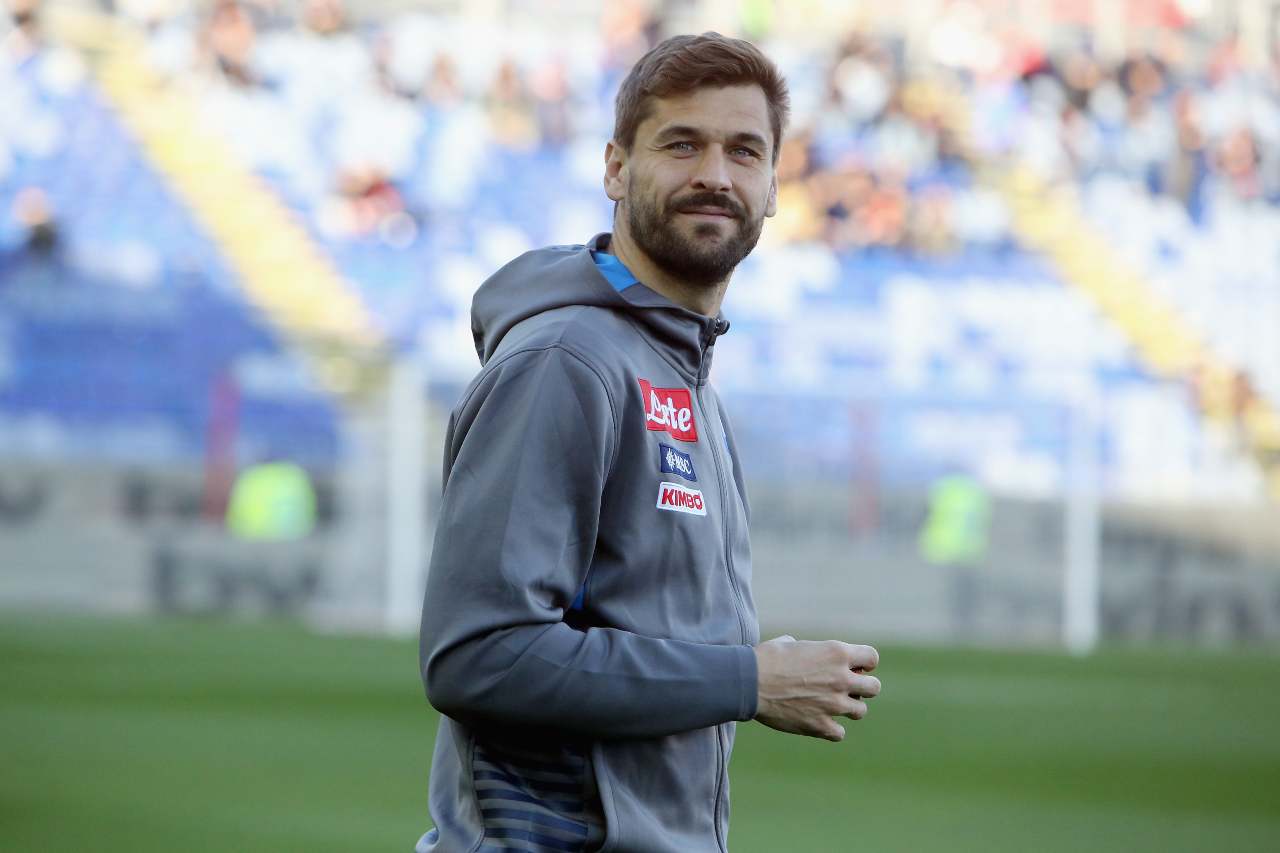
(420, 347, 756, 738)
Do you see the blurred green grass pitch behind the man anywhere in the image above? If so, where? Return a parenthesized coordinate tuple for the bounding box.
(0, 612, 1280, 853)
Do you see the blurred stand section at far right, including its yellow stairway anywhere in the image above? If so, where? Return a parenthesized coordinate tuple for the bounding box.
(975, 29, 1280, 488)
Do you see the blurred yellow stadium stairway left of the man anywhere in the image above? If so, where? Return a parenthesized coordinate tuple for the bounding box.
(51, 9, 387, 398)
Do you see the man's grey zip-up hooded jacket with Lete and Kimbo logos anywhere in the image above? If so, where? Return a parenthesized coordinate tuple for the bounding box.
(416, 234, 759, 853)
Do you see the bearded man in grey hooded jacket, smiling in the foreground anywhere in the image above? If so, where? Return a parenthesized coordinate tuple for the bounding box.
(417, 33, 879, 853)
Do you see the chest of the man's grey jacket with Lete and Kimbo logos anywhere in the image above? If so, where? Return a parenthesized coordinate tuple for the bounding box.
(591, 370, 755, 642)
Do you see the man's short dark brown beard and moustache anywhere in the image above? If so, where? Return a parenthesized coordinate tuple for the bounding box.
(626, 185, 764, 287)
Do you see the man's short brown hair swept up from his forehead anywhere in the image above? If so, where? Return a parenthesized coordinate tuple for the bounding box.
(613, 32, 791, 163)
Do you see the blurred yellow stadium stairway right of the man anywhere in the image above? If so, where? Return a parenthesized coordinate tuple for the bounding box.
(984, 167, 1280, 501)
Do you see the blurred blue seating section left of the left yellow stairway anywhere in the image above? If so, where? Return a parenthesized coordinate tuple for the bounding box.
(0, 6, 339, 465)
